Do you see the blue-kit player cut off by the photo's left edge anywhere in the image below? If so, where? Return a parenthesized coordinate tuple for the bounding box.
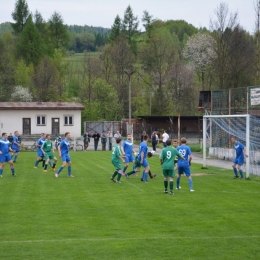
(0, 133, 16, 177)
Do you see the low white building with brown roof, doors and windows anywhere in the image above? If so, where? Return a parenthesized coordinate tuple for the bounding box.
(0, 102, 85, 137)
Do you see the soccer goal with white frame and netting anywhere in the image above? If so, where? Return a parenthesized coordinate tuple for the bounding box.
(203, 115, 260, 178)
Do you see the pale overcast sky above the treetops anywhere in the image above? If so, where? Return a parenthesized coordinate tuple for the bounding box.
(0, 0, 256, 33)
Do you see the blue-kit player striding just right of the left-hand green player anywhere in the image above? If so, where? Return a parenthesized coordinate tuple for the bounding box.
(55, 132, 74, 178)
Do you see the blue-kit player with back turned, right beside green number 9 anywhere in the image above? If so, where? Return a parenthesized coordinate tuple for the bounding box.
(176, 137, 194, 192)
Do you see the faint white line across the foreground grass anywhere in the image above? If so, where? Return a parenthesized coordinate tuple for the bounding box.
(0, 235, 260, 244)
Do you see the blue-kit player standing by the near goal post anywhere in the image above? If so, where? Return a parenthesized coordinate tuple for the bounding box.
(231, 136, 248, 179)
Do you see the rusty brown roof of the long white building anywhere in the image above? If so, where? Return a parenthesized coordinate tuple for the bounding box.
(0, 101, 85, 110)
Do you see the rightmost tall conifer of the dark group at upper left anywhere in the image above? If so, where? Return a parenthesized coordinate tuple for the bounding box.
(49, 12, 70, 49)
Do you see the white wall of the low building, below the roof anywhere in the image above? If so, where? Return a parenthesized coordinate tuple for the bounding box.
(0, 110, 81, 137)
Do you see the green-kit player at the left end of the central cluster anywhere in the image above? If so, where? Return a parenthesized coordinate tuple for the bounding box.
(110, 138, 125, 183)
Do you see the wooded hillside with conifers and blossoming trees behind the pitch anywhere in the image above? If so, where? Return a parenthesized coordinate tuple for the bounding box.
(0, 0, 260, 120)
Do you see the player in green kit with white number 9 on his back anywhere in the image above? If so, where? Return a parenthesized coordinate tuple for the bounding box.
(160, 139, 185, 195)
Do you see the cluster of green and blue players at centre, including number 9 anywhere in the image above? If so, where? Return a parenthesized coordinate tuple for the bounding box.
(110, 134, 194, 195)
